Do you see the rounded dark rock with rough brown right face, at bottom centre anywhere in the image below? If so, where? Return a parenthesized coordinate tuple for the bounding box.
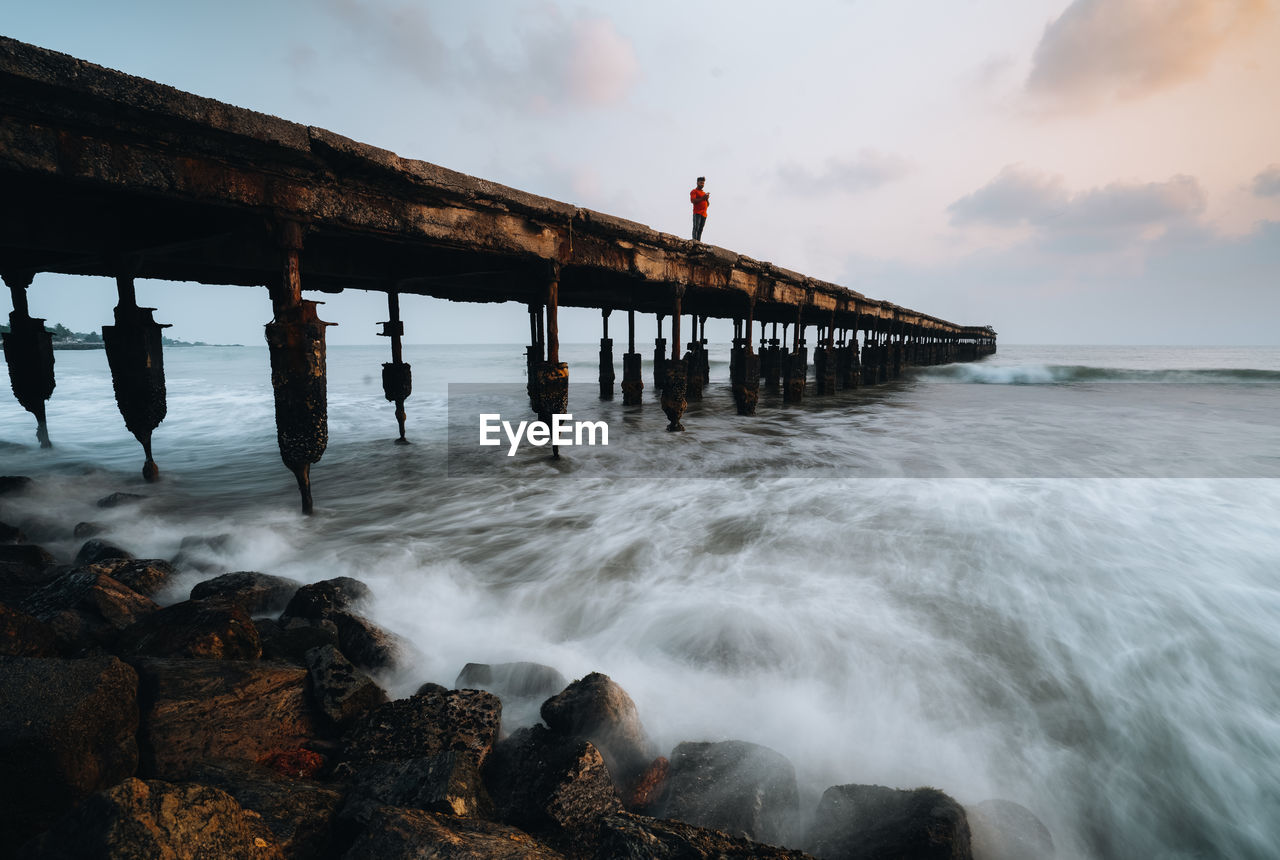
(484, 726, 622, 838)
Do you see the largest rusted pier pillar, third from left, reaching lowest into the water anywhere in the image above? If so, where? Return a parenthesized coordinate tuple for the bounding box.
(259, 221, 333, 513)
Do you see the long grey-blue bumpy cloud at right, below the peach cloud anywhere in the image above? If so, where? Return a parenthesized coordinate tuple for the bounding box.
(947, 165, 1206, 250)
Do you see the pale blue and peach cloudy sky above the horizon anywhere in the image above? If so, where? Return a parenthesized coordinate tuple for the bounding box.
(0, 0, 1280, 346)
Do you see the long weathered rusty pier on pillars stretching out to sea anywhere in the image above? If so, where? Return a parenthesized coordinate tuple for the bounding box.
(0, 37, 996, 512)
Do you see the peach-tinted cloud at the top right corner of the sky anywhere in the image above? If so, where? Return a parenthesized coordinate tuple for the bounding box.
(1027, 0, 1274, 108)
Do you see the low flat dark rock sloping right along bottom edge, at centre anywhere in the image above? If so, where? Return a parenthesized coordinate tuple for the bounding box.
(594, 813, 813, 860)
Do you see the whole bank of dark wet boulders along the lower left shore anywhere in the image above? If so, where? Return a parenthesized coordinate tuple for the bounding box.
(0, 477, 1053, 860)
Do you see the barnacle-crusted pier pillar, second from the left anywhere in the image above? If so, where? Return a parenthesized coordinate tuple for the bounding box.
(102, 274, 169, 481)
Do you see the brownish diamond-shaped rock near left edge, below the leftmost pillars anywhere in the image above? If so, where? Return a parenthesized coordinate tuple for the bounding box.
(18, 568, 159, 654)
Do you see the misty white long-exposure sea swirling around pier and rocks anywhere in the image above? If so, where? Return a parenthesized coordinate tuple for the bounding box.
(0, 343, 1280, 860)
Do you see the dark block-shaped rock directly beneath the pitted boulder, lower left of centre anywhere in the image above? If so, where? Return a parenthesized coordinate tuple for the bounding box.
(334, 750, 494, 819)
